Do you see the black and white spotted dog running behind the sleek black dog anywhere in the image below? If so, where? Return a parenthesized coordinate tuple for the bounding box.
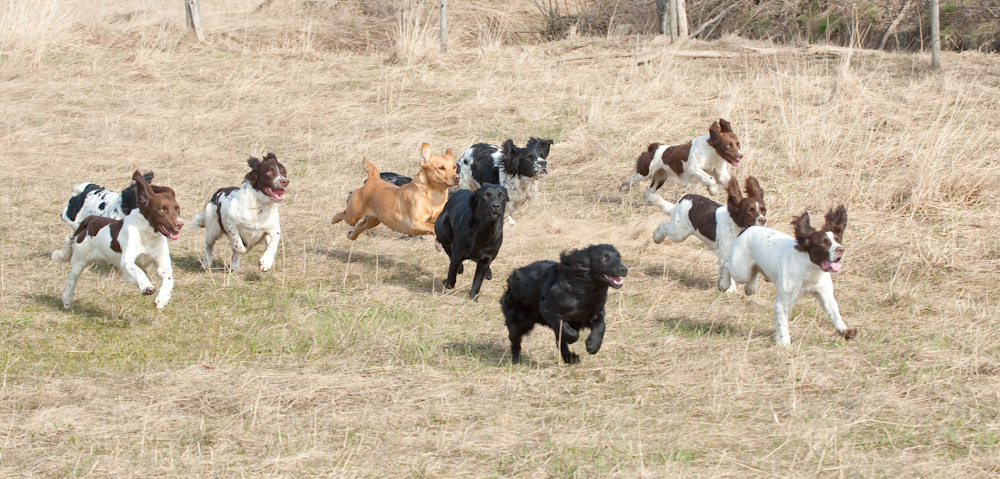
(458, 138, 552, 224)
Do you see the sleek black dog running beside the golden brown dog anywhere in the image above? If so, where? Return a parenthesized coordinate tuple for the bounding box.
(434, 183, 507, 298)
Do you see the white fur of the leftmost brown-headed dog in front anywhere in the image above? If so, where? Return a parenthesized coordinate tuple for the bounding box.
(52, 208, 174, 310)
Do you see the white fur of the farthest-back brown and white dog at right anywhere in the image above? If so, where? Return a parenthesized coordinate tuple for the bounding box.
(621, 135, 742, 214)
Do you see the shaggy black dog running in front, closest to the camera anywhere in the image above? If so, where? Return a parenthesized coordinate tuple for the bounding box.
(500, 244, 628, 364)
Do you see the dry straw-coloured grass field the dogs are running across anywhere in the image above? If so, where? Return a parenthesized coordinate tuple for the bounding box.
(0, 0, 1000, 478)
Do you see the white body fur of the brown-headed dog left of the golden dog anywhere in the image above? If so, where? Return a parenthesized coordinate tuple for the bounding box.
(194, 178, 281, 271)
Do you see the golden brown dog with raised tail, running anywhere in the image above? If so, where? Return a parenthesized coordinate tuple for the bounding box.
(333, 143, 459, 240)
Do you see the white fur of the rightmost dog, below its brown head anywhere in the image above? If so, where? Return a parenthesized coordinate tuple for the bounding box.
(719, 226, 847, 346)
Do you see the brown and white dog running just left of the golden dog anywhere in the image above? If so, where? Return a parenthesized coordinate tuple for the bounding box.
(194, 153, 288, 271)
